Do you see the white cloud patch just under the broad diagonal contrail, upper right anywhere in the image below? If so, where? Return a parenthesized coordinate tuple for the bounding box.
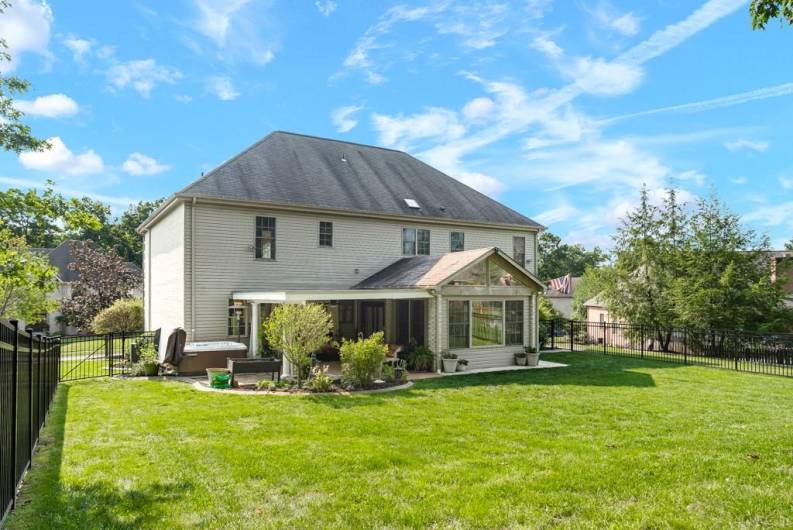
(566, 57, 643, 96)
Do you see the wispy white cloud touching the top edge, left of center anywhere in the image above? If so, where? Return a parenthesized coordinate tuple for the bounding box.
(193, 0, 278, 65)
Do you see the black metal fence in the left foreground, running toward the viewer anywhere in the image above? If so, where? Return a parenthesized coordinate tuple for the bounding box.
(0, 321, 60, 526)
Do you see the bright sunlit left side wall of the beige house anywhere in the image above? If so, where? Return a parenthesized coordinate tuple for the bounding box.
(144, 204, 186, 329)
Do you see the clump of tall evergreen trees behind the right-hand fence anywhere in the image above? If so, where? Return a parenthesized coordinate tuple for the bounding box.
(597, 190, 793, 332)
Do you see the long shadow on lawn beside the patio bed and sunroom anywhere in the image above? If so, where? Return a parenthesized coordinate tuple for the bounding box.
(306, 352, 682, 409)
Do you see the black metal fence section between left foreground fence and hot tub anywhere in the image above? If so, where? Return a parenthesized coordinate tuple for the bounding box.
(60, 331, 154, 381)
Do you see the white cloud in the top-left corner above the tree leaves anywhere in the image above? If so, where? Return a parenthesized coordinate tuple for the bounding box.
(0, 0, 53, 73)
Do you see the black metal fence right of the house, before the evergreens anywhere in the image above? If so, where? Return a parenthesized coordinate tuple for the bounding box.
(540, 319, 793, 377)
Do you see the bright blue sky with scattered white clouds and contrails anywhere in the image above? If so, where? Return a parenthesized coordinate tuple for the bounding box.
(0, 0, 793, 247)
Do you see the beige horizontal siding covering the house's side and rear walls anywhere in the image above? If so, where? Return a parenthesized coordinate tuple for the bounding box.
(145, 200, 536, 340)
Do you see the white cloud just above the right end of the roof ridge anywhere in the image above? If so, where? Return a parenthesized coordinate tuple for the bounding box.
(372, 107, 465, 148)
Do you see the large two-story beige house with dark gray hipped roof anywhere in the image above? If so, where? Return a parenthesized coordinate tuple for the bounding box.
(139, 132, 543, 367)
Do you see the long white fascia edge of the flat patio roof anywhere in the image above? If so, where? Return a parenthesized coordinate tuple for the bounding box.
(232, 289, 433, 304)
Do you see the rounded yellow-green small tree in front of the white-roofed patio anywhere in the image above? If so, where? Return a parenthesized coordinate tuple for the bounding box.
(263, 304, 333, 385)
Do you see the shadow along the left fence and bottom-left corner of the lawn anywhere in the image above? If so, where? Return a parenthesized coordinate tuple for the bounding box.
(6, 384, 192, 529)
